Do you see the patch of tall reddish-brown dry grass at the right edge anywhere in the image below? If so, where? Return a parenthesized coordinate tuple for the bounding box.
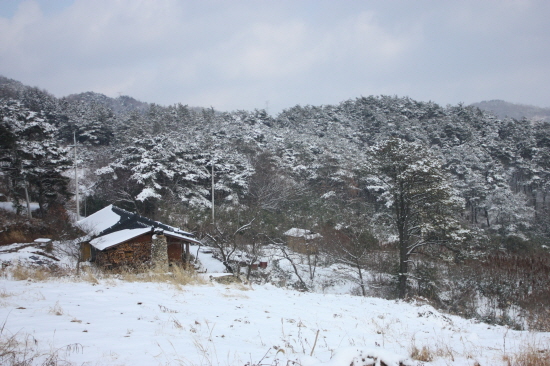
(446, 252, 550, 332)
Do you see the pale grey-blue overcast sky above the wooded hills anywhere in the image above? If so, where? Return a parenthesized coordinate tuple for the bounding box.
(0, 0, 550, 114)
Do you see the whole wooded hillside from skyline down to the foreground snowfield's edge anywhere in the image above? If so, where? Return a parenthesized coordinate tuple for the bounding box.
(0, 76, 550, 340)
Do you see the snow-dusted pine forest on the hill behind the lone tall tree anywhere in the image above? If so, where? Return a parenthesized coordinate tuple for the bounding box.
(0, 74, 550, 247)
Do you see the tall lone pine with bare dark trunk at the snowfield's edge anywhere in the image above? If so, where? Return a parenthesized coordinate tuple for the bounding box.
(368, 138, 467, 298)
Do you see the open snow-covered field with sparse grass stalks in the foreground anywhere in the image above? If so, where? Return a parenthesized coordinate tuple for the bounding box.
(0, 278, 550, 366)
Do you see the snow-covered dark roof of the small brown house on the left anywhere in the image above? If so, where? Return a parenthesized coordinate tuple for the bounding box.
(77, 205, 200, 250)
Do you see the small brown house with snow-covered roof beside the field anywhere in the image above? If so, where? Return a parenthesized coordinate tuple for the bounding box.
(77, 205, 200, 267)
